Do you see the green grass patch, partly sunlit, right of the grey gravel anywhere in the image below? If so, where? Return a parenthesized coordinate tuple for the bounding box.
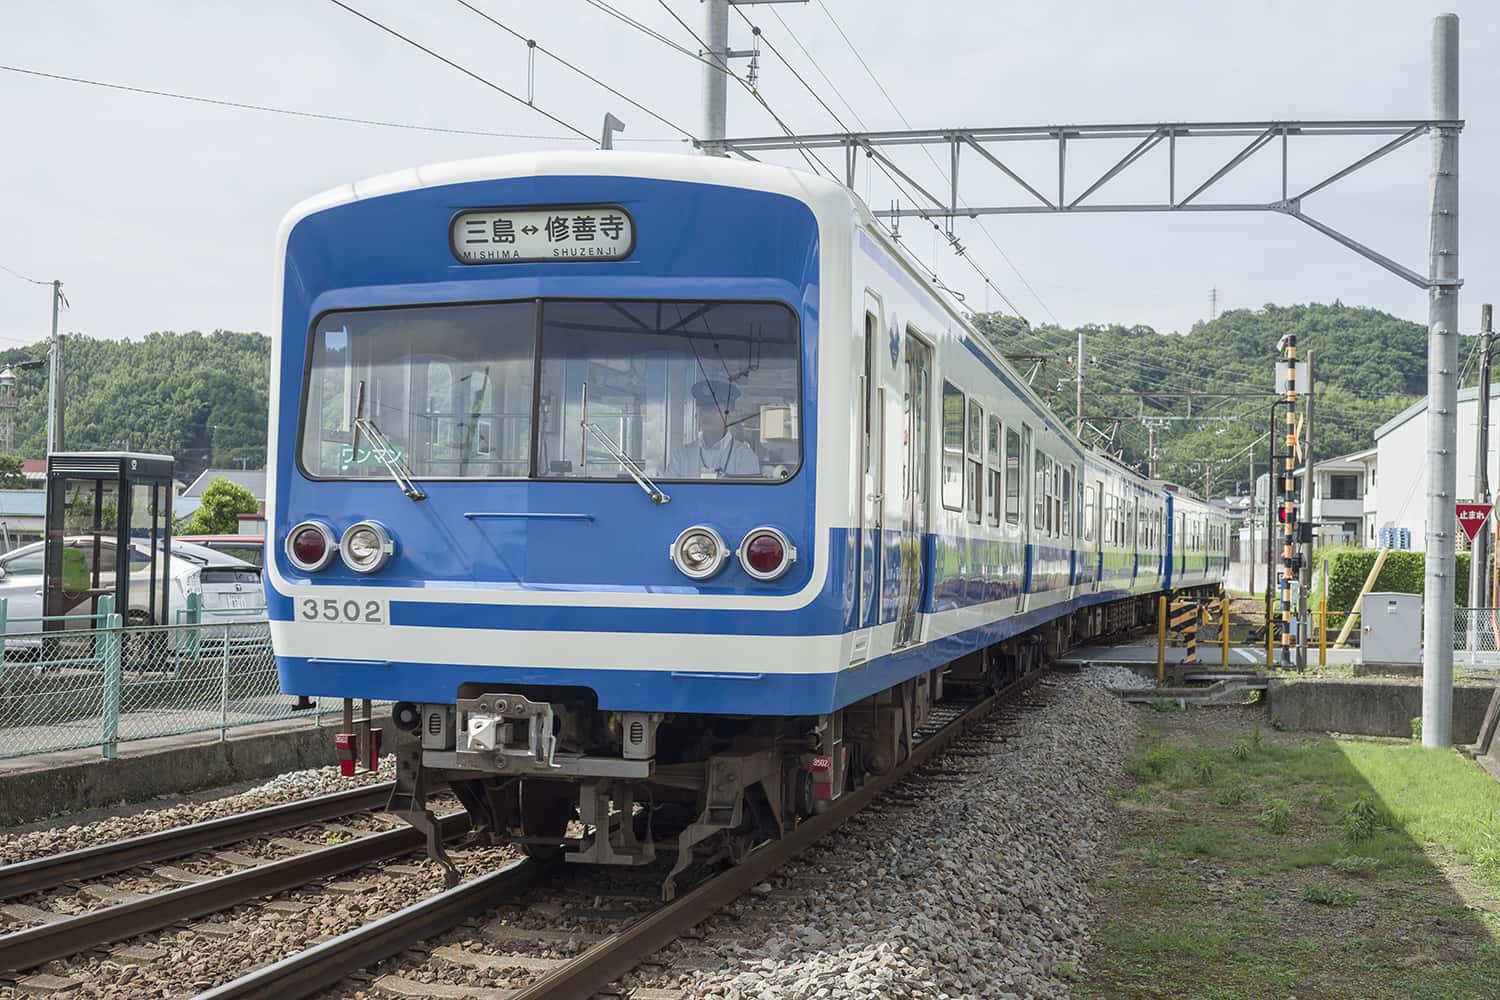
(1064, 709, 1500, 1000)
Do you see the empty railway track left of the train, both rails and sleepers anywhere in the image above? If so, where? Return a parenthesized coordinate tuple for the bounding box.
(0, 783, 468, 972)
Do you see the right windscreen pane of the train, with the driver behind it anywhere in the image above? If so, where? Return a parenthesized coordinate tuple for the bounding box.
(537, 301, 801, 483)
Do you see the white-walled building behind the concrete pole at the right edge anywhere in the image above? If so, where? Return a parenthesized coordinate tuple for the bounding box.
(1374, 382, 1500, 549)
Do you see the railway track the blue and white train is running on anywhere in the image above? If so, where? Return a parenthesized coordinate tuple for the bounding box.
(201, 672, 1043, 1000)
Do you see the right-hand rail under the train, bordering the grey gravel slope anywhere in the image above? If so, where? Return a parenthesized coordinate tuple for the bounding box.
(510, 670, 1046, 1000)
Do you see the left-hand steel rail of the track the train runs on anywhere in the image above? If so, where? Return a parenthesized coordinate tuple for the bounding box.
(198, 859, 554, 1000)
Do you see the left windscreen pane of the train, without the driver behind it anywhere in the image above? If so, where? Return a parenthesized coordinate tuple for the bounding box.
(300, 301, 537, 480)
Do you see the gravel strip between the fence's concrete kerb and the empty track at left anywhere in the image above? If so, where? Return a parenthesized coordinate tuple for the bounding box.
(0, 757, 396, 865)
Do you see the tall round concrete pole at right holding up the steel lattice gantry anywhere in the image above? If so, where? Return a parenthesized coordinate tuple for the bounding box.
(1422, 13, 1458, 748)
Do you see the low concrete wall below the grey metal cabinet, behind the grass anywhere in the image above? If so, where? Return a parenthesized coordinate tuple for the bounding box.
(1268, 679, 1496, 744)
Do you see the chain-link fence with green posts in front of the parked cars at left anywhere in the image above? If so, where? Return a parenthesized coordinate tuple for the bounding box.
(0, 615, 342, 757)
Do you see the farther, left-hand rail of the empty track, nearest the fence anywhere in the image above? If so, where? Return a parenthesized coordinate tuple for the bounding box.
(0, 781, 395, 900)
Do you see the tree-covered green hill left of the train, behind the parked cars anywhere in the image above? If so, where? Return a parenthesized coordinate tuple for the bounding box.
(0, 330, 272, 480)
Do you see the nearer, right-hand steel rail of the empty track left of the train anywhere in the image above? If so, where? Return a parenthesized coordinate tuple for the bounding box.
(0, 813, 470, 972)
